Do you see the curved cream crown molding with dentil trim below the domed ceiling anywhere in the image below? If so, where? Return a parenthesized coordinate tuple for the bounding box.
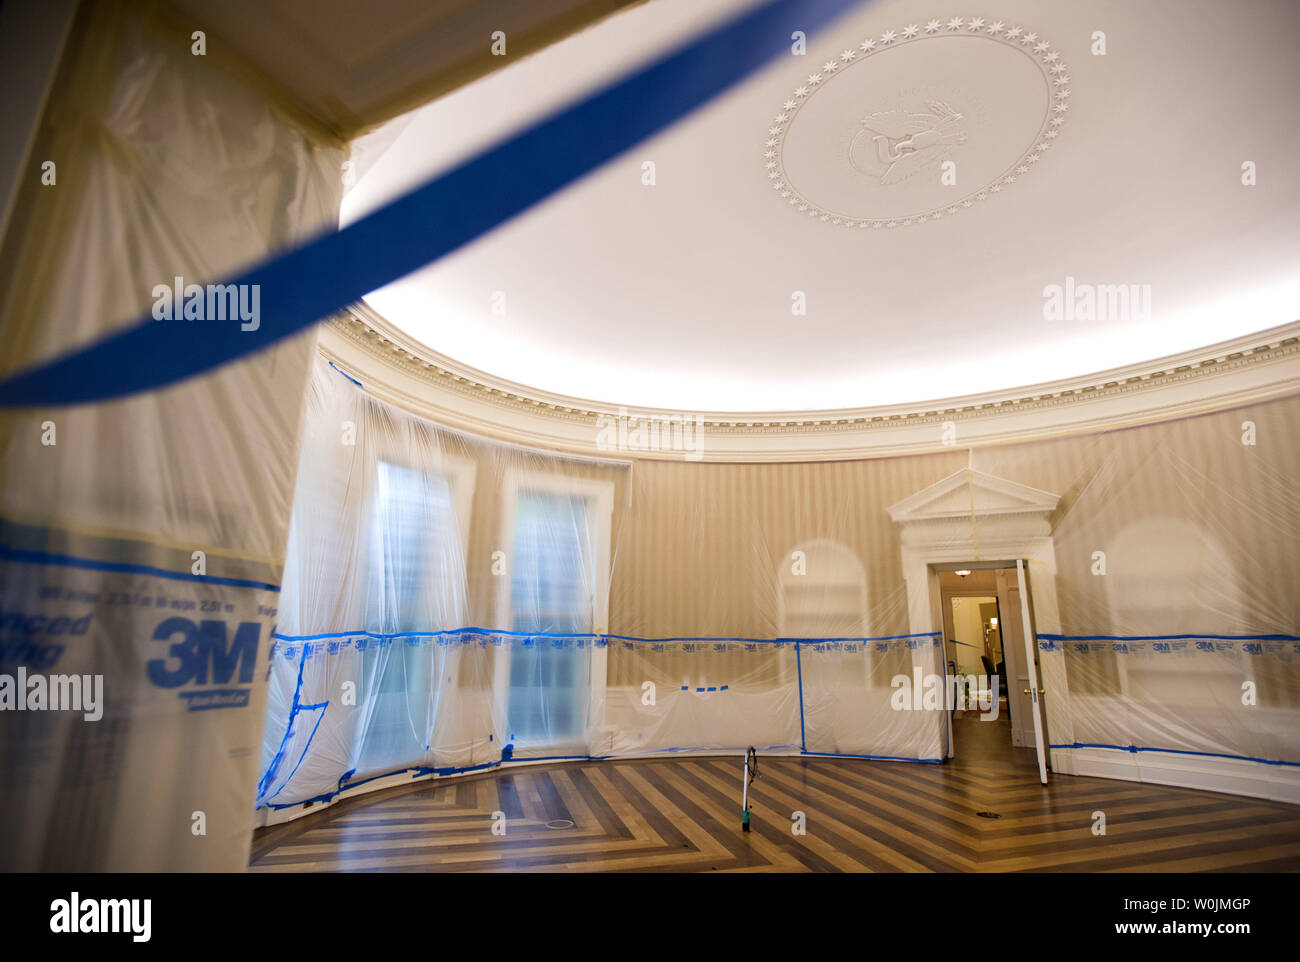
(319, 303, 1300, 462)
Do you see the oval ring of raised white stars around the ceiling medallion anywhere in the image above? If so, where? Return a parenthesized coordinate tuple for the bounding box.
(763, 17, 1071, 230)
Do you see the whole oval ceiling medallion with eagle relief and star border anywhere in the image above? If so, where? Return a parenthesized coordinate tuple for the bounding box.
(763, 17, 1070, 228)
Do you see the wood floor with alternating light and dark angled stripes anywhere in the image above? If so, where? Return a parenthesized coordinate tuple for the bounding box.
(251, 720, 1300, 872)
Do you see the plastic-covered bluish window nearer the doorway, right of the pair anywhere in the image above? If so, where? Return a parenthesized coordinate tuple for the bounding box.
(502, 473, 612, 749)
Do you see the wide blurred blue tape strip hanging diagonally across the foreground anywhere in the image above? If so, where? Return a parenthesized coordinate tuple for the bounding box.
(0, 0, 861, 407)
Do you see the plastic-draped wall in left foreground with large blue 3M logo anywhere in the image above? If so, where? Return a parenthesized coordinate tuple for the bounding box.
(0, 3, 345, 871)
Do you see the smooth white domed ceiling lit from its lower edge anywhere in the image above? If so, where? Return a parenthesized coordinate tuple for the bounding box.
(342, 0, 1300, 411)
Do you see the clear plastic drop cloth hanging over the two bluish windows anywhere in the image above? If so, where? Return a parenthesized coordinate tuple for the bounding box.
(257, 360, 629, 807)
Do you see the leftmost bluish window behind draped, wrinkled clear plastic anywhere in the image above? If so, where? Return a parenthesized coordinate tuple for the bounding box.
(354, 462, 472, 774)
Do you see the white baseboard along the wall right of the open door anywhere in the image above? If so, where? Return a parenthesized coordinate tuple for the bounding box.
(1052, 748, 1300, 805)
